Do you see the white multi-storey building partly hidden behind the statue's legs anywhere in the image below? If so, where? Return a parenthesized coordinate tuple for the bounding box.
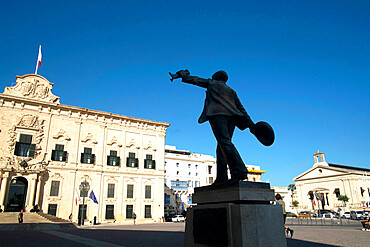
(165, 145, 265, 215)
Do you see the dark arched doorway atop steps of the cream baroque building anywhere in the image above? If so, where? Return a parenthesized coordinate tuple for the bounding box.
(5, 177, 28, 212)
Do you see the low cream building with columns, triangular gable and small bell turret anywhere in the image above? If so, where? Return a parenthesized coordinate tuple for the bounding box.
(293, 151, 370, 211)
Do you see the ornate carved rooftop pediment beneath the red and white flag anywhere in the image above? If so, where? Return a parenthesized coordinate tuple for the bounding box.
(4, 74, 60, 104)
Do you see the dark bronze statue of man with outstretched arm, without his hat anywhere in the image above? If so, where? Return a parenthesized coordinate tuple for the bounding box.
(170, 70, 254, 184)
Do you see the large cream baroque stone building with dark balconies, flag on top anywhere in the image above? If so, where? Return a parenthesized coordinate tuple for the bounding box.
(0, 74, 169, 222)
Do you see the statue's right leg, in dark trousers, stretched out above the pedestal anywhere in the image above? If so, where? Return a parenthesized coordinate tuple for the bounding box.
(209, 116, 248, 180)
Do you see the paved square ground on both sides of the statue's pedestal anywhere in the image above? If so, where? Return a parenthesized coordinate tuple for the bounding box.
(0, 222, 370, 247)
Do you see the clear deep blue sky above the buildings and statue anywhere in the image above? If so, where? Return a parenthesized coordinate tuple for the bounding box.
(0, 0, 370, 186)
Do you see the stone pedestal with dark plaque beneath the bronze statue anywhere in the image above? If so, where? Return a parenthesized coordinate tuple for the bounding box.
(185, 182, 287, 247)
